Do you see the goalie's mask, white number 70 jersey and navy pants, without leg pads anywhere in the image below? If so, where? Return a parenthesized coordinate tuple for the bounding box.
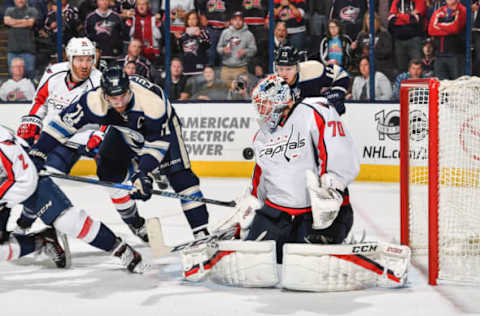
(246, 76, 360, 263)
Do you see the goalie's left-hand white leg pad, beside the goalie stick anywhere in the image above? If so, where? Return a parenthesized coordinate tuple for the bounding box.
(210, 240, 279, 287)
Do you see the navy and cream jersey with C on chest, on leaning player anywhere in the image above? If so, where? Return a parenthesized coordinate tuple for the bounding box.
(34, 76, 176, 172)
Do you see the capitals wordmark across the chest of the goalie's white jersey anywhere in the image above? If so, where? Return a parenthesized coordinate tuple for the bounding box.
(259, 125, 306, 162)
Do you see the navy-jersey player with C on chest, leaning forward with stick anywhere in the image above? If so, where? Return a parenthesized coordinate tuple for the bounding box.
(31, 66, 208, 241)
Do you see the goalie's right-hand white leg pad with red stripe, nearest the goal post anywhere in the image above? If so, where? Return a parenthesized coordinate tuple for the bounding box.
(282, 242, 410, 292)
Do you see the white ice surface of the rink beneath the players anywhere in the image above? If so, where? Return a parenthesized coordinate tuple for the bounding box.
(0, 178, 480, 316)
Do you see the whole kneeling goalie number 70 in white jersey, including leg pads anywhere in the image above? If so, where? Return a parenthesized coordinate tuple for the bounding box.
(182, 75, 410, 291)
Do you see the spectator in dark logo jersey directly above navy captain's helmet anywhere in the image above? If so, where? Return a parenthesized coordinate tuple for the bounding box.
(85, 0, 127, 63)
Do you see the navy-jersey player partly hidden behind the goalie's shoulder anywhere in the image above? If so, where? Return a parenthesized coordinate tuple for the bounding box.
(275, 46, 350, 115)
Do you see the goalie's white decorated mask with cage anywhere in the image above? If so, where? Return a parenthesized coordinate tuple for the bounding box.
(252, 75, 293, 131)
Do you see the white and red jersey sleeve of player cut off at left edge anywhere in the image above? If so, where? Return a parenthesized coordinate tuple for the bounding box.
(0, 125, 38, 207)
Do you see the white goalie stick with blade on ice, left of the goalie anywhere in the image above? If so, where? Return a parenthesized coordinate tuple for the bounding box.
(146, 217, 240, 257)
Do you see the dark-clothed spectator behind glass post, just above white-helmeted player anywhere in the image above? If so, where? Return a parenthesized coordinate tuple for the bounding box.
(40, 0, 83, 45)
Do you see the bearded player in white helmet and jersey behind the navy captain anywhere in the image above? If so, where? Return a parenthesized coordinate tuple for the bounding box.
(17, 37, 103, 235)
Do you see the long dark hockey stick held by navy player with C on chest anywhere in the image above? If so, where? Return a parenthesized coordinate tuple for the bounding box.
(46, 173, 237, 207)
